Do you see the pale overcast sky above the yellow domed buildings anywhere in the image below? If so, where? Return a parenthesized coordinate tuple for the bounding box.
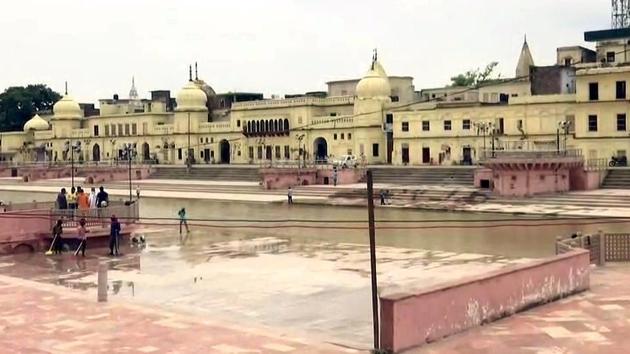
(0, 0, 610, 102)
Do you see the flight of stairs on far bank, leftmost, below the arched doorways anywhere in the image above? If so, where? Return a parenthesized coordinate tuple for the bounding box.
(150, 166, 260, 182)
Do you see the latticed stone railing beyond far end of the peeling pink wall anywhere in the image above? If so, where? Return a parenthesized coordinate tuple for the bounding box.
(556, 231, 630, 265)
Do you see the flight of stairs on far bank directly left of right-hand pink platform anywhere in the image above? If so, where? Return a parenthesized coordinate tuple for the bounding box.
(372, 167, 475, 186)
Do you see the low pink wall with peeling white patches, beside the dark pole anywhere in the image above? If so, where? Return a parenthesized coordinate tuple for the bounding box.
(381, 250, 590, 352)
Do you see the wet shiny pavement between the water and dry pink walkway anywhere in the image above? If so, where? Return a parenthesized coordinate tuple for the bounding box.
(0, 229, 527, 348)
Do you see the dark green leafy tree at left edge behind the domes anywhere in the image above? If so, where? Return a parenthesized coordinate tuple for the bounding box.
(0, 84, 61, 131)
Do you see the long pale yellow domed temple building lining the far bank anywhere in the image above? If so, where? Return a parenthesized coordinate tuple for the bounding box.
(0, 29, 630, 165)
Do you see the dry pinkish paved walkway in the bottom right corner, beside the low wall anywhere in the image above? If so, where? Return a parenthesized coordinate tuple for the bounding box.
(406, 264, 630, 354)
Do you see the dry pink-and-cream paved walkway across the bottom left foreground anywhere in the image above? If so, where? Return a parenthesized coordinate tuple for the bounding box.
(0, 276, 357, 354)
